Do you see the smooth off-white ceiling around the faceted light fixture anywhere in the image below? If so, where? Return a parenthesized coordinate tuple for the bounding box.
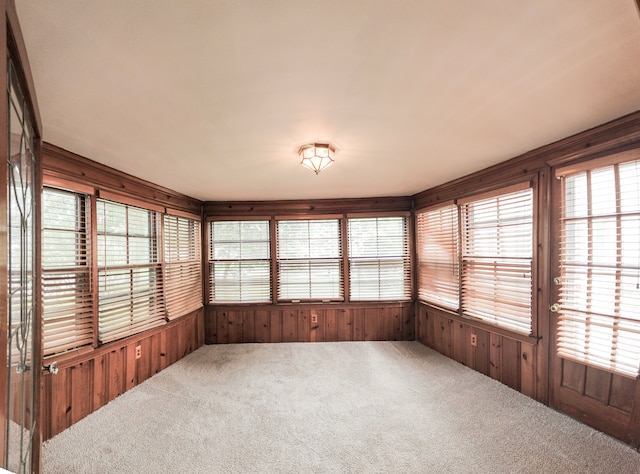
(17, 0, 640, 200)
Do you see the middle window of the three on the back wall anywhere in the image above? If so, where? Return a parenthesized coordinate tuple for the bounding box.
(277, 219, 344, 301)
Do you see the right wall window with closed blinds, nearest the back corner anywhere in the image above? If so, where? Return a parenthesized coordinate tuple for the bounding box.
(416, 203, 460, 311)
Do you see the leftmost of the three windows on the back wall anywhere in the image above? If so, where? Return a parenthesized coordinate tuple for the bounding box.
(209, 220, 271, 303)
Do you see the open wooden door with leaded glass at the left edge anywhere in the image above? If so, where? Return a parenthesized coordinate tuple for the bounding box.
(0, 0, 42, 473)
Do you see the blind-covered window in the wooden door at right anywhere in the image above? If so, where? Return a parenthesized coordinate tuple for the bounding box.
(557, 161, 640, 378)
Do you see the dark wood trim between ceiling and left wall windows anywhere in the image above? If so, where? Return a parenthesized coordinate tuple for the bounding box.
(42, 142, 202, 215)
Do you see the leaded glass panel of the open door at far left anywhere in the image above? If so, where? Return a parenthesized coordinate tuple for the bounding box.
(5, 59, 36, 473)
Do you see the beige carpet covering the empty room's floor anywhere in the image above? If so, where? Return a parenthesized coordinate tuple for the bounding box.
(43, 342, 640, 474)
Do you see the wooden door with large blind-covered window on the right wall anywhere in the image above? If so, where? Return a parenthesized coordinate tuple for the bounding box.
(550, 150, 640, 447)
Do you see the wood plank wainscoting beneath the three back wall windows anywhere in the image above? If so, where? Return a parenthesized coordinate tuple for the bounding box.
(204, 302, 415, 344)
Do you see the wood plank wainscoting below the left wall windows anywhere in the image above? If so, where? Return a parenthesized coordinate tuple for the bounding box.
(41, 309, 204, 441)
